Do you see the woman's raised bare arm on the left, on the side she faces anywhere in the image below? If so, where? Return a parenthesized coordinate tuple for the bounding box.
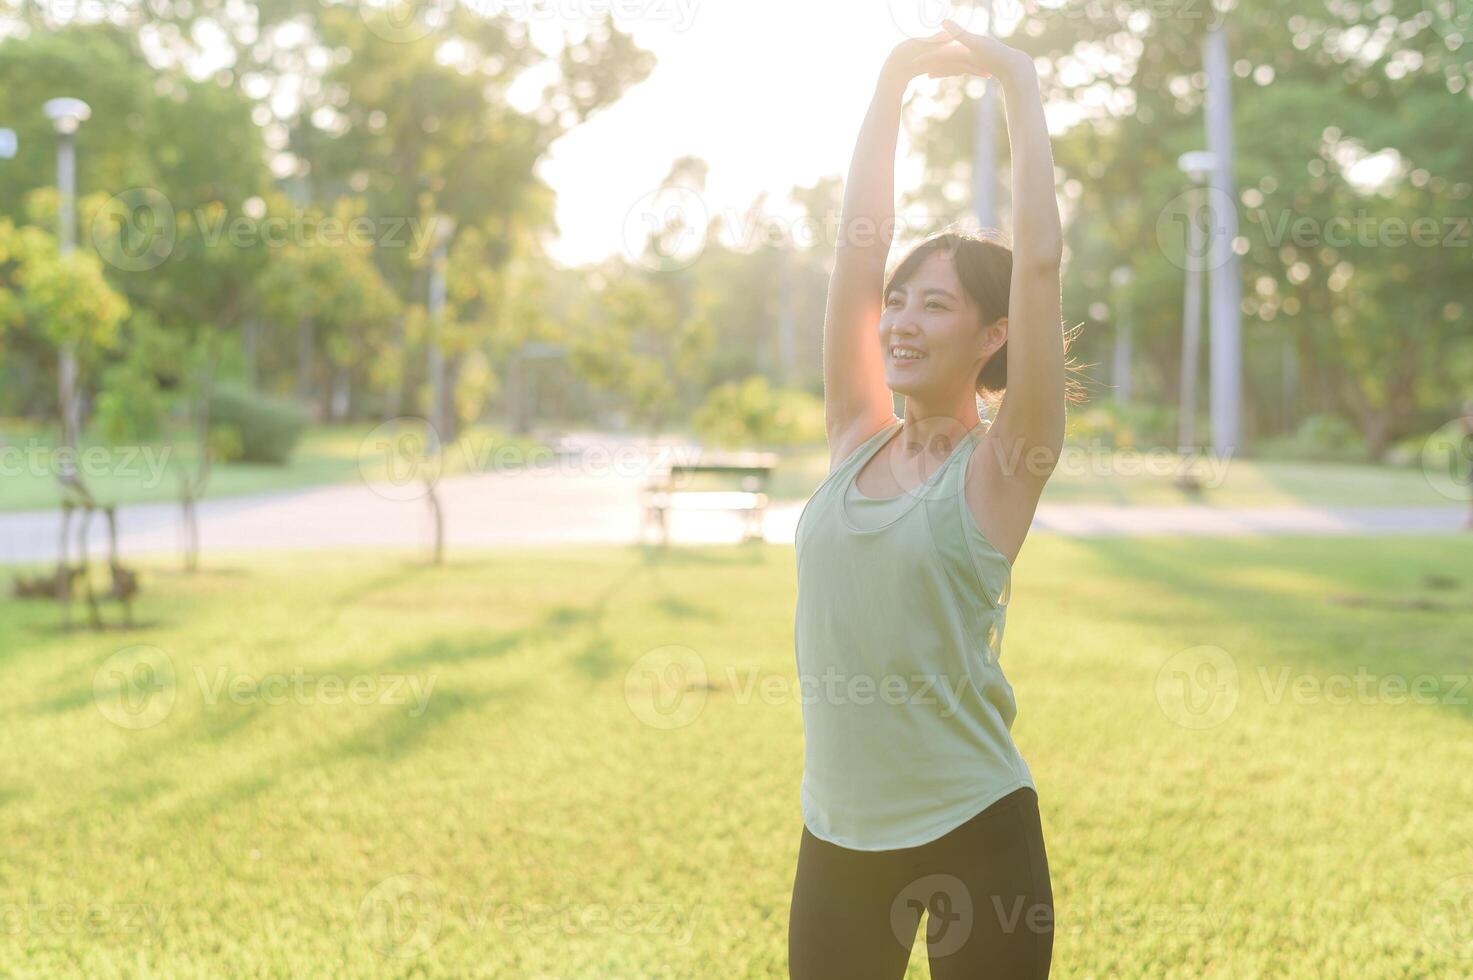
(823, 32, 955, 466)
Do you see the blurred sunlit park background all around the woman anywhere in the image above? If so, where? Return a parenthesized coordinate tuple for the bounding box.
(0, 0, 1473, 977)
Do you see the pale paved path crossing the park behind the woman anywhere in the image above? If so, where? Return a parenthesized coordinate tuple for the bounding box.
(0, 466, 1467, 563)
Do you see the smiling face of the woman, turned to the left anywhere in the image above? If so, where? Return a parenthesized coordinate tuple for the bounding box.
(879, 252, 990, 398)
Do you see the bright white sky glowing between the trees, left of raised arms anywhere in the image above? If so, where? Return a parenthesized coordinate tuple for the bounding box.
(535, 0, 978, 264)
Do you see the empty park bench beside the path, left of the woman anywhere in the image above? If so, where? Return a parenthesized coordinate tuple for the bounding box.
(641, 452, 778, 545)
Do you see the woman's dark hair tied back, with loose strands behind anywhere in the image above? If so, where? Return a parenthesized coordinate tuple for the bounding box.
(881, 228, 1084, 414)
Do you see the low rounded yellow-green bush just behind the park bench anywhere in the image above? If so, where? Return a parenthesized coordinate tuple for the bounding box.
(691, 376, 823, 448)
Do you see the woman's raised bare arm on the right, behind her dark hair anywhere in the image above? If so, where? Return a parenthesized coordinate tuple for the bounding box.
(946, 21, 1065, 491)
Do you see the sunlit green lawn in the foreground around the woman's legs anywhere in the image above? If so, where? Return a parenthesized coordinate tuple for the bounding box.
(0, 535, 1473, 980)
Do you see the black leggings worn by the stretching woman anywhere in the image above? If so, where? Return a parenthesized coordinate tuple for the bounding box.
(788, 787, 1053, 980)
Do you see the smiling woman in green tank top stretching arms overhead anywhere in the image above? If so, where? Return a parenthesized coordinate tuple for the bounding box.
(788, 21, 1084, 980)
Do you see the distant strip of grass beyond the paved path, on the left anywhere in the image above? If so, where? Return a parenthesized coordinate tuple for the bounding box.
(0, 424, 536, 511)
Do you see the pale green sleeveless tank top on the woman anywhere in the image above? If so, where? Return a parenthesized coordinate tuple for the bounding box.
(794, 419, 1033, 850)
